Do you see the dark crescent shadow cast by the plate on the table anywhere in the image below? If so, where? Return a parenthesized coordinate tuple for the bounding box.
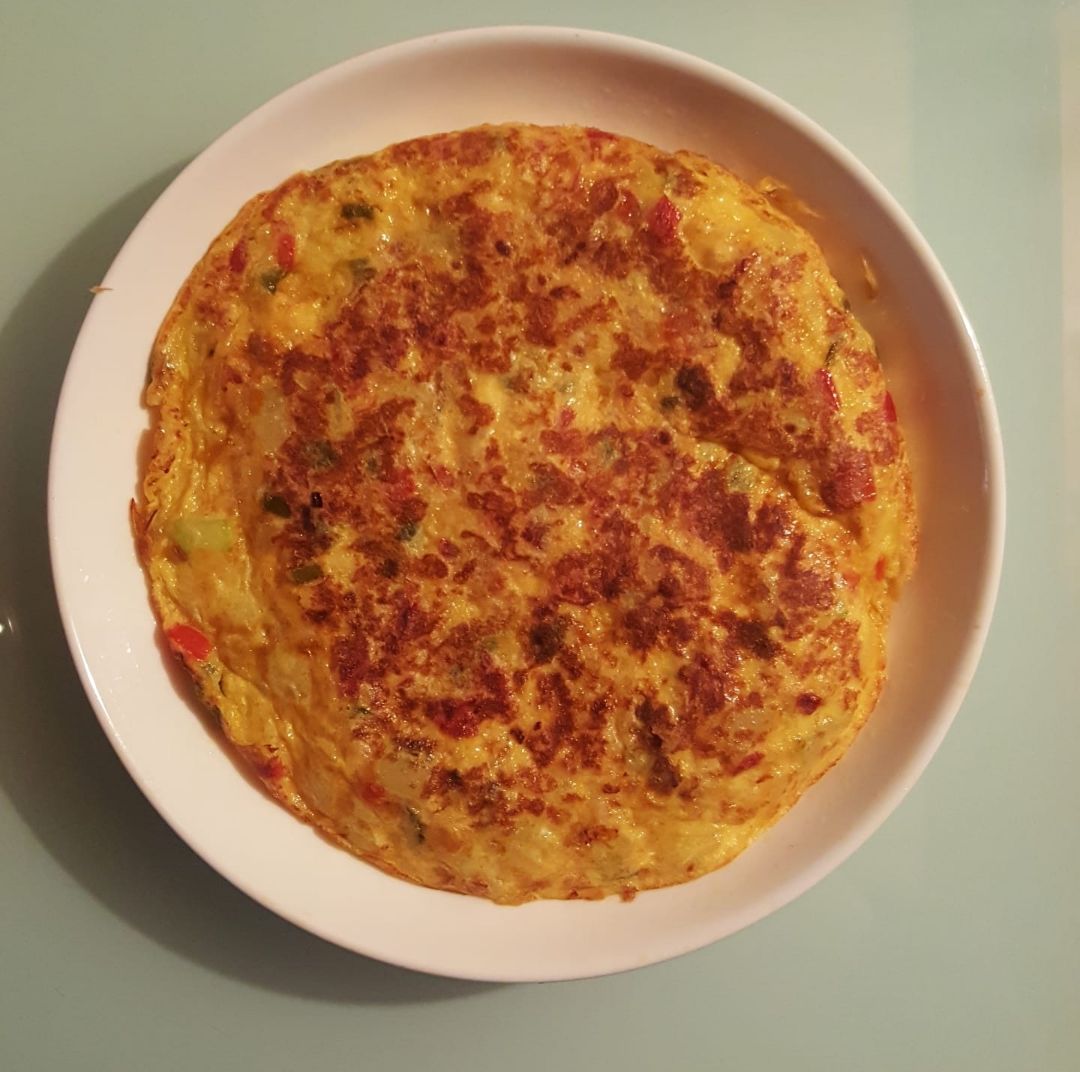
(0, 164, 492, 1004)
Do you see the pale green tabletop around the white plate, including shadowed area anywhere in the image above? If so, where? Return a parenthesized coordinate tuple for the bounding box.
(0, 0, 1080, 1072)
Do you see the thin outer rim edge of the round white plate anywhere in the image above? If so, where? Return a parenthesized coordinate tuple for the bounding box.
(48, 26, 1005, 981)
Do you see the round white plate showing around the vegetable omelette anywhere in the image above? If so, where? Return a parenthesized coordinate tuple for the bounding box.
(49, 28, 1003, 980)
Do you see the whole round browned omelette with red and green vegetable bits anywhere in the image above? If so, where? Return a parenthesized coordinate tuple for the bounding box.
(133, 125, 916, 903)
